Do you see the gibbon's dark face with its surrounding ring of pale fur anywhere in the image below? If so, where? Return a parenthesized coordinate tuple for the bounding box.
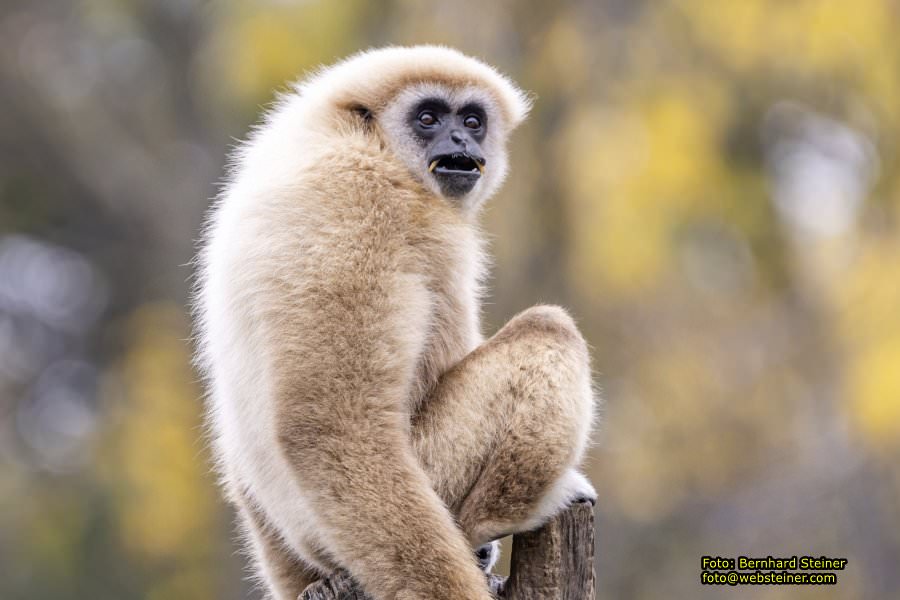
(376, 83, 508, 209)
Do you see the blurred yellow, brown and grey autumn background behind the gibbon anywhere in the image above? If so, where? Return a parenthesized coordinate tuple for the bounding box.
(0, 0, 900, 600)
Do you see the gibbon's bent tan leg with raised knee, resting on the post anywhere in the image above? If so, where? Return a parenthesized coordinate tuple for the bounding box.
(412, 306, 596, 546)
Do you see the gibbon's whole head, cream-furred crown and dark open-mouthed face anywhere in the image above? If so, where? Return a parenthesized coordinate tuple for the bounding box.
(299, 46, 530, 209)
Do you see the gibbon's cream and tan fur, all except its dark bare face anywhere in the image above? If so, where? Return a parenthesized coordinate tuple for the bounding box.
(196, 47, 593, 600)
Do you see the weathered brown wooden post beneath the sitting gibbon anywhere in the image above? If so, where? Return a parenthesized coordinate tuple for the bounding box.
(298, 502, 594, 600)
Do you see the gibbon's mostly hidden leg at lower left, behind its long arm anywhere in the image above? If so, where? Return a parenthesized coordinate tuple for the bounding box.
(236, 495, 321, 600)
